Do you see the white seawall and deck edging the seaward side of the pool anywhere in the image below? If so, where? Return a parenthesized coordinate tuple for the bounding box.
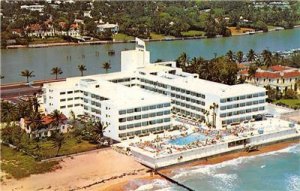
(130, 118, 300, 169)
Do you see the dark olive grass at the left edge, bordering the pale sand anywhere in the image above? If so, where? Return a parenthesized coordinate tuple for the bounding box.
(1, 145, 59, 179)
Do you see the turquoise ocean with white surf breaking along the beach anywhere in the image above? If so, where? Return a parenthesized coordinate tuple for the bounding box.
(130, 144, 300, 191)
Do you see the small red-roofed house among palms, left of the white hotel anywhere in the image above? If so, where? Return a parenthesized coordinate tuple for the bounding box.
(20, 114, 70, 138)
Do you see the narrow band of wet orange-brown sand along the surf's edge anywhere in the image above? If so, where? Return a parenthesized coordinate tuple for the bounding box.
(102, 140, 300, 191)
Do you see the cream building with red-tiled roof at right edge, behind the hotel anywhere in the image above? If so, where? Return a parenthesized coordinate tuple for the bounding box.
(238, 65, 300, 93)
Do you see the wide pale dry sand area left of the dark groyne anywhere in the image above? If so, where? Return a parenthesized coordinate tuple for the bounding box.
(0, 148, 148, 191)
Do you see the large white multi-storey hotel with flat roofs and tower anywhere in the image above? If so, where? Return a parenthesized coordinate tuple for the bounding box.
(43, 40, 266, 141)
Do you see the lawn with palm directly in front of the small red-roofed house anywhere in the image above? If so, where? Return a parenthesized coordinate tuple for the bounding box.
(29, 135, 97, 159)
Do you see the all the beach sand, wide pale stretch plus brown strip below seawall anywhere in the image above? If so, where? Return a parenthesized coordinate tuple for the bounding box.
(1, 140, 299, 191)
